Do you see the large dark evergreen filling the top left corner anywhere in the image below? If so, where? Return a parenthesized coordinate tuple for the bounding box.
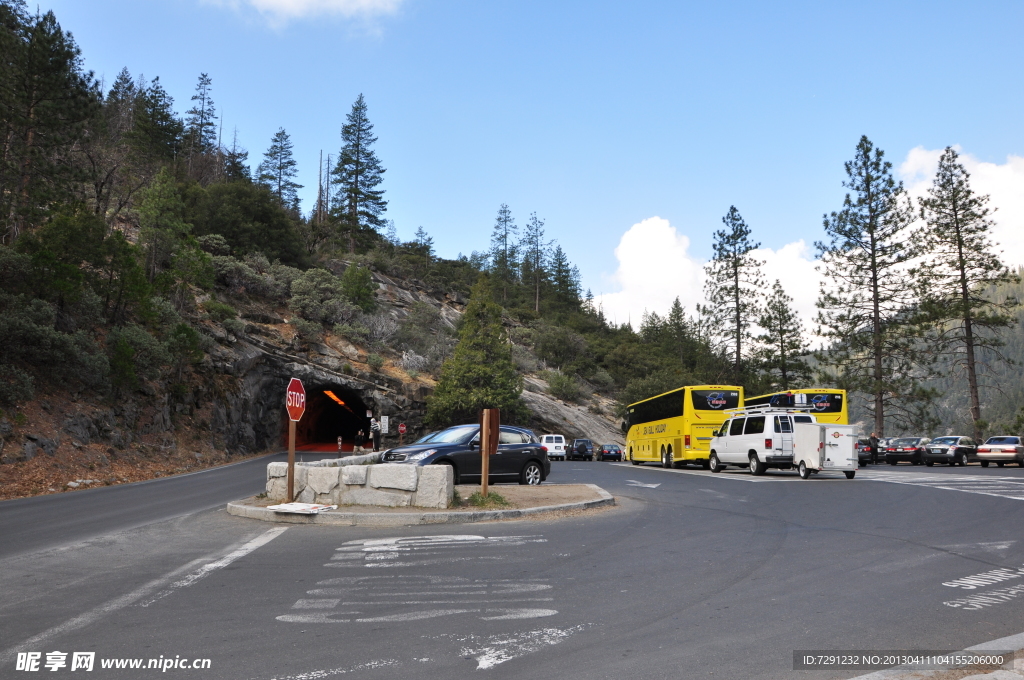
(0, 2, 100, 244)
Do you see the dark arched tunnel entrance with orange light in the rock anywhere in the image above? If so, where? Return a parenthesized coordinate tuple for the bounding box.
(283, 384, 370, 452)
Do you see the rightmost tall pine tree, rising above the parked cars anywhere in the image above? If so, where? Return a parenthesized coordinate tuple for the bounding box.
(918, 146, 1020, 440)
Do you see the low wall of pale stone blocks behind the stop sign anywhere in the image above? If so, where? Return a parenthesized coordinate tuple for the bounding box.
(266, 456, 455, 508)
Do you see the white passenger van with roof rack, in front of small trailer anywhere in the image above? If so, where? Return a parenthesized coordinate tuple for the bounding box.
(708, 407, 817, 474)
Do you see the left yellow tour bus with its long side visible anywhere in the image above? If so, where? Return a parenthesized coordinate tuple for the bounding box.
(623, 385, 743, 469)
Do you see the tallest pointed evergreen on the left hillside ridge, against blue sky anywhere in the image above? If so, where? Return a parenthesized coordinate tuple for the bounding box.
(331, 94, 387, 252)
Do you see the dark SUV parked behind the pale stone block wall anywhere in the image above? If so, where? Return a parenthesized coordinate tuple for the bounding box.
(382, 424, 551, 484)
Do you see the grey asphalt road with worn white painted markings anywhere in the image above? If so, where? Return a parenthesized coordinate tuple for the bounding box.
(0, 460, 1024, 680)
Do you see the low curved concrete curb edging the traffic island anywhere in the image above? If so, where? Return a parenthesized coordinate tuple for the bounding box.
(227, 484, 615, 526)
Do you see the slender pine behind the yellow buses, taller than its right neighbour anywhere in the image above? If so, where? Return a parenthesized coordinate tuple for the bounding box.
(705, 206, 764, 384)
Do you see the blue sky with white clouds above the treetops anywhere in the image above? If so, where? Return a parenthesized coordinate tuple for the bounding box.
(34, 0, 1024, 325)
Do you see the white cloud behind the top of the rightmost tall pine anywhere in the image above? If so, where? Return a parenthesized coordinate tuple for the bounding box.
(899, 146, 1024, 265)
